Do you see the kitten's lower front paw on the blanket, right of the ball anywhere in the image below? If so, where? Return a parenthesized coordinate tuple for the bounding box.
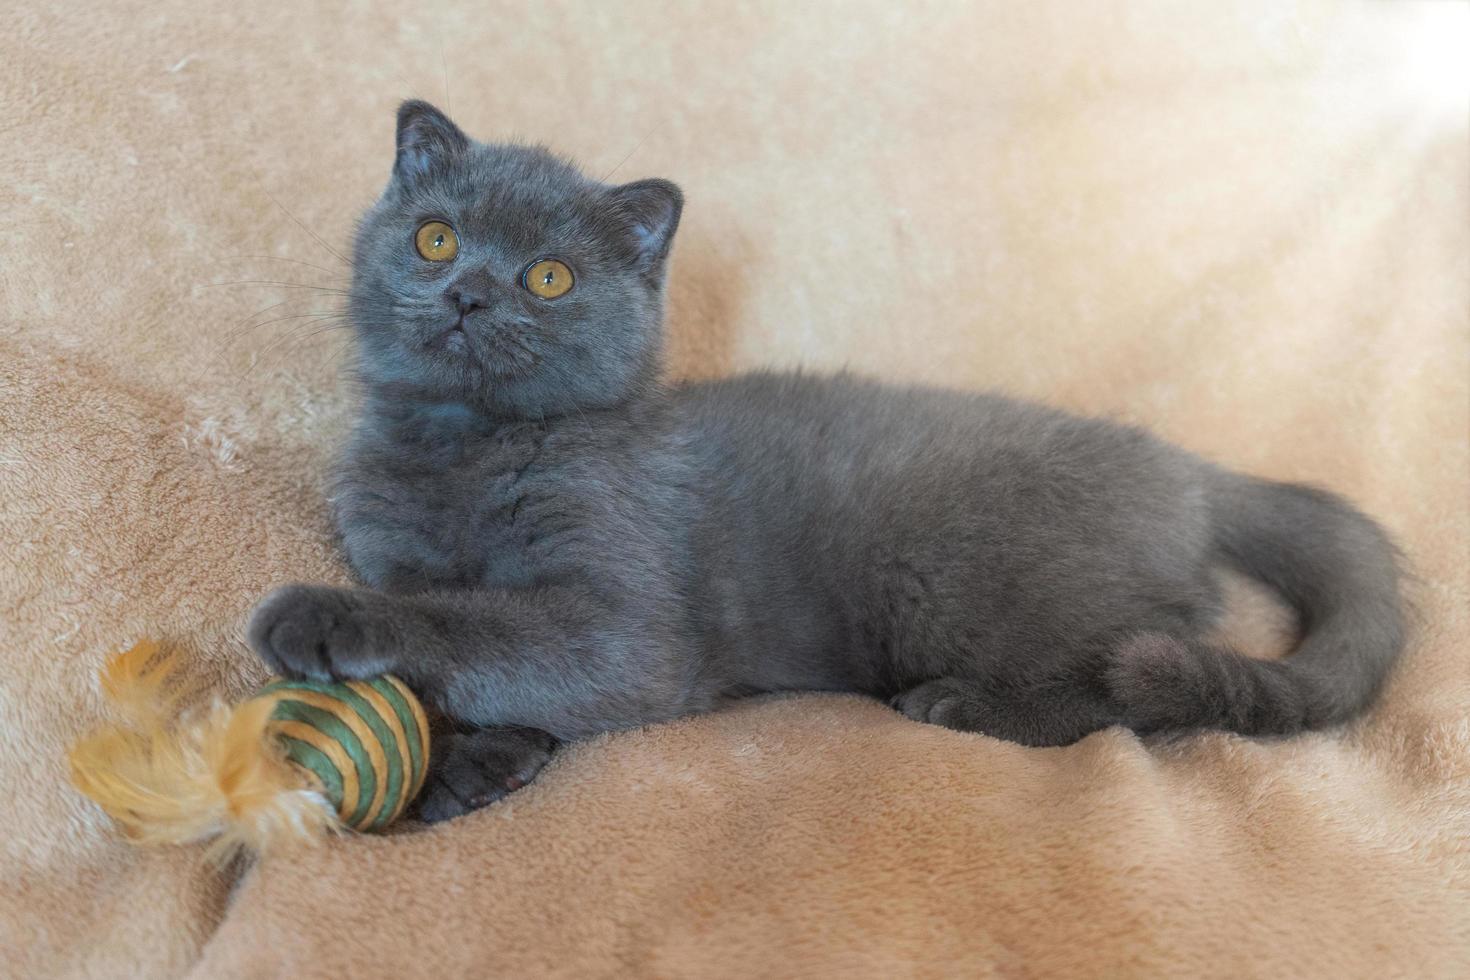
(417, 727, 557, 823)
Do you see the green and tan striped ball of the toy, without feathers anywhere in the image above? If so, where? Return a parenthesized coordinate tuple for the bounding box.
(256, 674, 429, 830)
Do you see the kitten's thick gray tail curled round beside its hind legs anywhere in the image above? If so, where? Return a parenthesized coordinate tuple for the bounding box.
(1108, 470, 1407, 735)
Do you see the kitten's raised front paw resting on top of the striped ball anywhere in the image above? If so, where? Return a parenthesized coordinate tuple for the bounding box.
(245, 585, 391, 680)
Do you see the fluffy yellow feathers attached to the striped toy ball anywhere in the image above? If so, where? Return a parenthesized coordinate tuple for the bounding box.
(69, 644, 341, 858)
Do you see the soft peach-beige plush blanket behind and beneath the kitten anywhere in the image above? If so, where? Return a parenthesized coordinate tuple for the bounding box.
(0, 0, 1470, 977)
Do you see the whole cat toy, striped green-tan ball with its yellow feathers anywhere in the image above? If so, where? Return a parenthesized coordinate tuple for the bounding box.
(69, 641, 429, 855)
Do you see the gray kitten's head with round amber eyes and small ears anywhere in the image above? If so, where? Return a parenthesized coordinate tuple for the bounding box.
(350, 101, 684, 417)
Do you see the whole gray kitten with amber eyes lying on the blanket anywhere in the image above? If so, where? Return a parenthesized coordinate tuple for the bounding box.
(248, 101, 1404, 820)
